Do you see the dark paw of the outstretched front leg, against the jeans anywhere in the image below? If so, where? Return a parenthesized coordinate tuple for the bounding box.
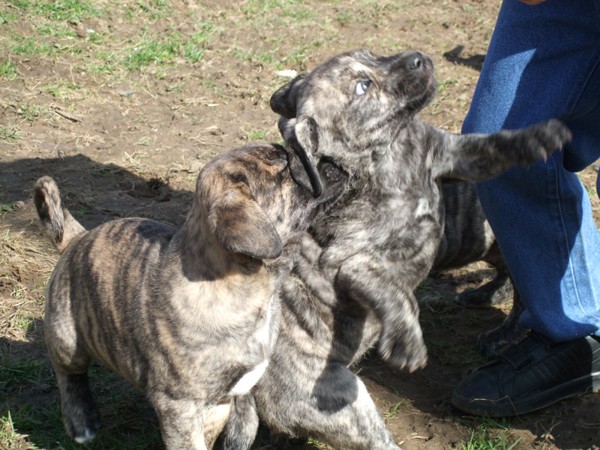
(522, 119, 572, 163)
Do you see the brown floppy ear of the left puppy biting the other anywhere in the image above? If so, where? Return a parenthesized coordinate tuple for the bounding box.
(208, 181, 283, 259)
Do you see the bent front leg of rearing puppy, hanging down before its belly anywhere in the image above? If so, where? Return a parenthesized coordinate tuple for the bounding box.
(335, 254, 427, 372)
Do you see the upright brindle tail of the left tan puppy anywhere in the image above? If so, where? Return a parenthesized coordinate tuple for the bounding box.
(33, 177, 86, 253)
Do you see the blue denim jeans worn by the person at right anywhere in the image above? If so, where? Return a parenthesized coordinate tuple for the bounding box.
(463, 0, 600, 341)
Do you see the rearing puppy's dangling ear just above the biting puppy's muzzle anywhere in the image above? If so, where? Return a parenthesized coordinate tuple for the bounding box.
(279, 115, 323, 197)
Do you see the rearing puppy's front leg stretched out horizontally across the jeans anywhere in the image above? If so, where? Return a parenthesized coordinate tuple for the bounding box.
(430, 120, 571, 182)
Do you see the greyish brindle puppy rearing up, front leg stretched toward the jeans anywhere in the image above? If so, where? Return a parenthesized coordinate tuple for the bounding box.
(214, 50, 570, 450)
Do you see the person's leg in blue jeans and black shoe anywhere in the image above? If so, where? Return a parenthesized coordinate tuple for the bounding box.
(452, 0, 600, 416)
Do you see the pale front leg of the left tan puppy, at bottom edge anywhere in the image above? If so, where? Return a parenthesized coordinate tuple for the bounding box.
(150, 393, 207, 450)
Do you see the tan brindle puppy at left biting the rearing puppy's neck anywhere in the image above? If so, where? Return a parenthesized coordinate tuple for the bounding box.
(34, 145, 347, 449)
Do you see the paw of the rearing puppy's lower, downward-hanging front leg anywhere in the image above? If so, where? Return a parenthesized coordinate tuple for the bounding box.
(379, 326, 427, 372)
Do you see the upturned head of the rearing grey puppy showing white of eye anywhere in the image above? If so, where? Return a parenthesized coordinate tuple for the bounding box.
(270, 50, 436, 175)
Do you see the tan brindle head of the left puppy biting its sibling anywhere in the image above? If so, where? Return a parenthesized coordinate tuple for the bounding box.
(194, 144, 348, 259)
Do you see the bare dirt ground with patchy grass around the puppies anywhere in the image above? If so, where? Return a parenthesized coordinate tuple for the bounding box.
(0, 0, 600, 450)
